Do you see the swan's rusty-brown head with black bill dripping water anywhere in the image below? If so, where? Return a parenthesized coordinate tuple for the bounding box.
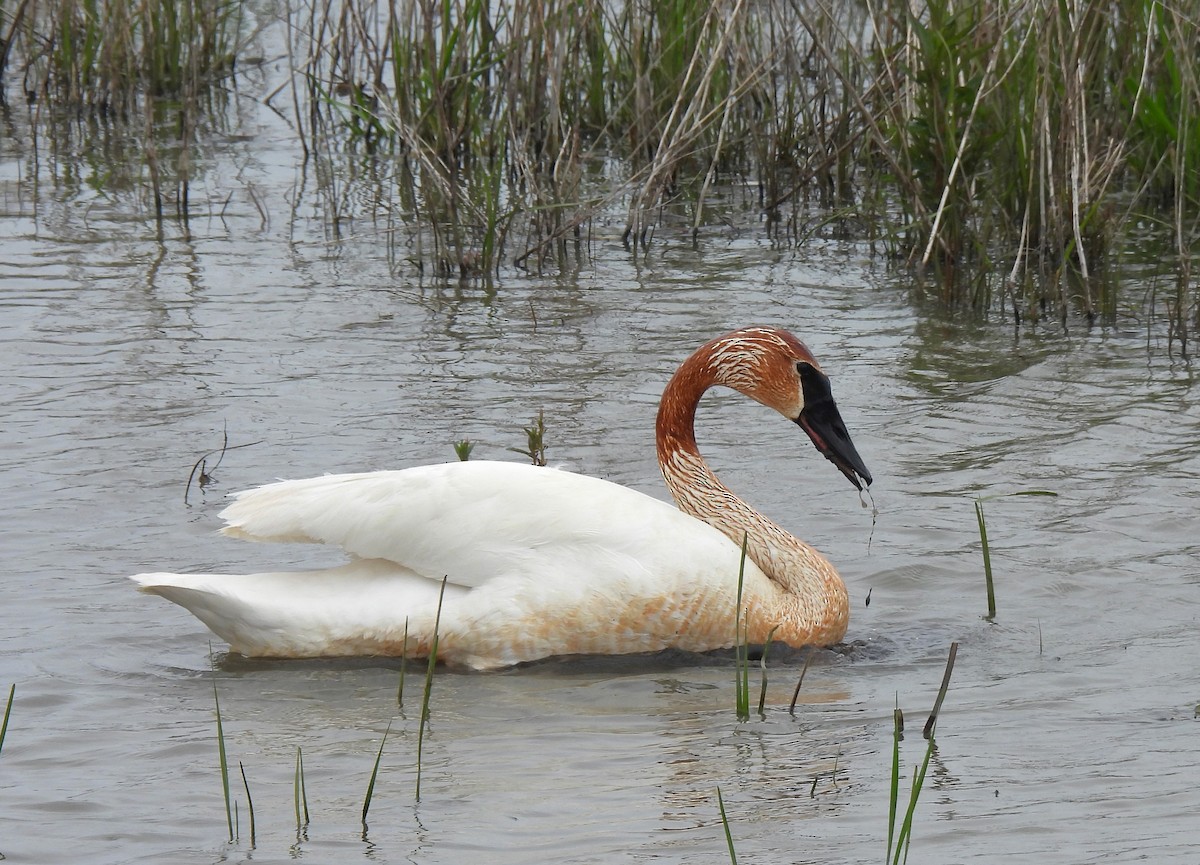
(701, 328, 872, 489)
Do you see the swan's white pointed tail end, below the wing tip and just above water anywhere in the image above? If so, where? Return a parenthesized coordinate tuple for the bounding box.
(131, 560, 463, 657)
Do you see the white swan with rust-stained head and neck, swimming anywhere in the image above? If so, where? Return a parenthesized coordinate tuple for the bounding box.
(132, 328, 871, 669)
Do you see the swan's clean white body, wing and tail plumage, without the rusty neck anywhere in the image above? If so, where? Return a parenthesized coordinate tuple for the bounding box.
(133, 461, 767, 667)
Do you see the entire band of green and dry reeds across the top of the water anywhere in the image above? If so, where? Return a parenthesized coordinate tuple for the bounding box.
(0, 0, 1200, 340)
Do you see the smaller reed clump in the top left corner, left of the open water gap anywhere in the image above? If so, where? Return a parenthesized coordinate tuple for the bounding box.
(0, 0, 256, 231)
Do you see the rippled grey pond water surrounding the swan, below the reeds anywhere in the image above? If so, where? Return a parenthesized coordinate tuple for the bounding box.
(0, 79, 1200, 864)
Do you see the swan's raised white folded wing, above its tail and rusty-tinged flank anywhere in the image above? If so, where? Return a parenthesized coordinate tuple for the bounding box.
(213, 461, 732, 587)
